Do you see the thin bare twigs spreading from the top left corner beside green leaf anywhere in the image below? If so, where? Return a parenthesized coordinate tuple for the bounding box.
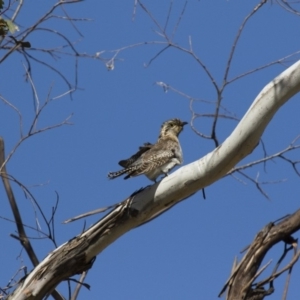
(0, 0, 102, 98)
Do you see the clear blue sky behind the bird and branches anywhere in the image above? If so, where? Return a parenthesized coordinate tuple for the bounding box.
(0, 0, 300, 299)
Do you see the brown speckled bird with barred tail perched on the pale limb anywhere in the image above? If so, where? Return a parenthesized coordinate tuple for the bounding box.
(108, 119, 188, 182)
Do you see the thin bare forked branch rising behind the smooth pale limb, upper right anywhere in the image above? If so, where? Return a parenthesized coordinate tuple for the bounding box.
(103, 0, 300, 147)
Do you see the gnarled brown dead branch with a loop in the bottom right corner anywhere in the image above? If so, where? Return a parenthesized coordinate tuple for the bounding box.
(219, 210, 300, 300)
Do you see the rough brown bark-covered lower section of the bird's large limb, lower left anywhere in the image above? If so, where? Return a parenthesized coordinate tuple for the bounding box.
(8, 195, 137, 300)
